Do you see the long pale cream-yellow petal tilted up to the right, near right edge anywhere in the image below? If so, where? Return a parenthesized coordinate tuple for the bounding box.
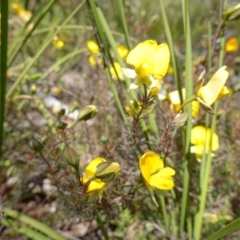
(197, 66, 229, 106)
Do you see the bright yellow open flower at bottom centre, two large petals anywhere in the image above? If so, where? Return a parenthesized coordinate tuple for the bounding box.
(139, 151, 175, 191)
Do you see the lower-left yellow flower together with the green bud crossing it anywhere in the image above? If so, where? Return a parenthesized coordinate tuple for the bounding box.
(80, 157, 120, 197)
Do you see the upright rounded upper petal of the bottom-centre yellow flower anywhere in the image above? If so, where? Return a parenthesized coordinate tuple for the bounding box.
(139, 151, 163, 183)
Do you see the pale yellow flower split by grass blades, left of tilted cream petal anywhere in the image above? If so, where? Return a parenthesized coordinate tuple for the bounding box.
(168, 88, 200, 117)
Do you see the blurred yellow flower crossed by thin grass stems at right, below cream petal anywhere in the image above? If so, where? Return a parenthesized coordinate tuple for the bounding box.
(191, 126, 219, 158)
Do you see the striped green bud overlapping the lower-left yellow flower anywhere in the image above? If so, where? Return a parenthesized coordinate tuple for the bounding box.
(94, 162, 120, 182)
